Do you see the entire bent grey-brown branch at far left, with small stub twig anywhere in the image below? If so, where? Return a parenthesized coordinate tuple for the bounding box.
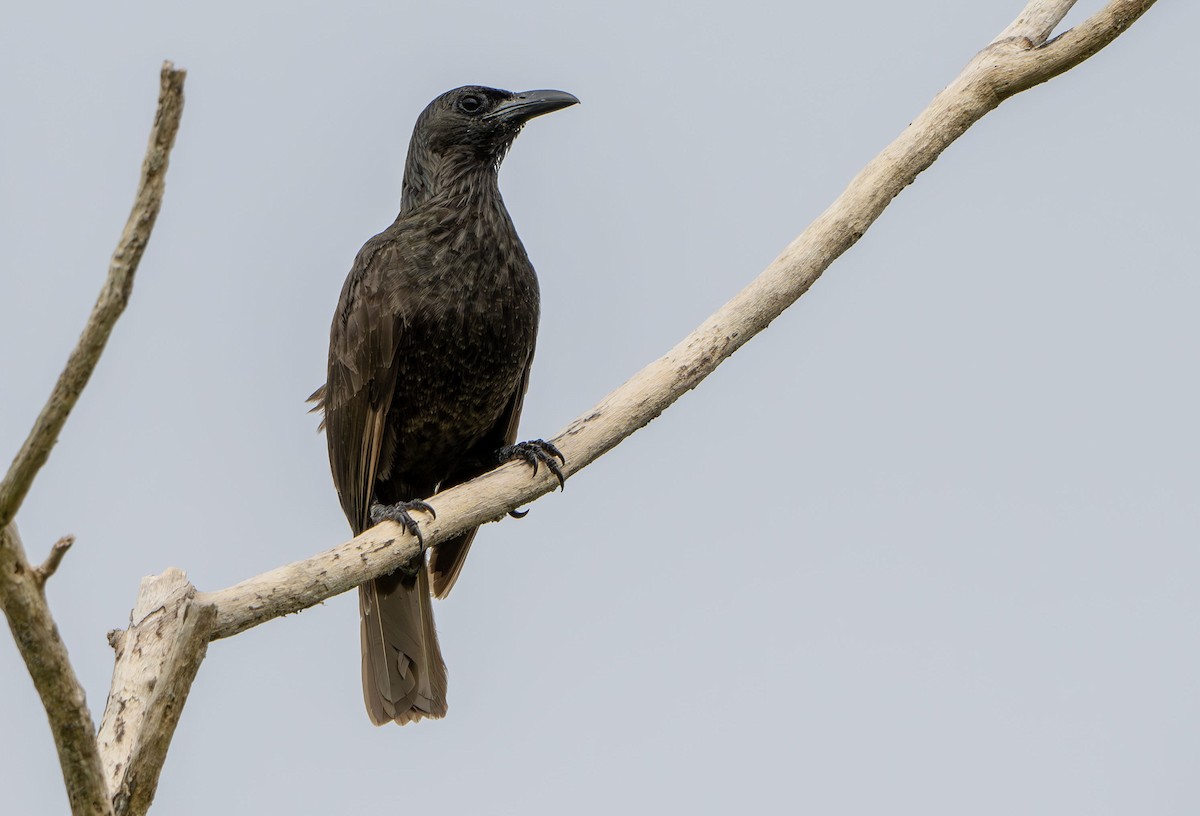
(0, 62, 185, 816)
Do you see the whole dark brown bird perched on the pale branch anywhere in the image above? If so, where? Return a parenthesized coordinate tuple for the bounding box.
(310, 85, 578, 725)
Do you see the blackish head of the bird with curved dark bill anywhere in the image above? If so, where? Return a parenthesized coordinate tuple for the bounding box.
(404, 85, 580, 203)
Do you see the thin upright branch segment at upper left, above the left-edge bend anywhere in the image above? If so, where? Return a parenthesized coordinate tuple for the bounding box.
(0, 62, 187, 527)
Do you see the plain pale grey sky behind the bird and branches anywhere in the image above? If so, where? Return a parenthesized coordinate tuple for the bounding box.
(0, 0, 1200, 816)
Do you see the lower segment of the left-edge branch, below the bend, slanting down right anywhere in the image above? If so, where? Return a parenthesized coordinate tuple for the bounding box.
(0, 524, 113, 816)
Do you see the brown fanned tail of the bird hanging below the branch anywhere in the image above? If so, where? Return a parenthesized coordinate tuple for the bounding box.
(359, 563, 446, 725)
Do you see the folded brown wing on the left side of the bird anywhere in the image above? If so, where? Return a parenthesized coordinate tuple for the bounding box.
(324, 232, 404, 535)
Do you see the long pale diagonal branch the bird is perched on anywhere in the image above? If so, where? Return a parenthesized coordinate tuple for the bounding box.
(197, 0, 1153, 638)
